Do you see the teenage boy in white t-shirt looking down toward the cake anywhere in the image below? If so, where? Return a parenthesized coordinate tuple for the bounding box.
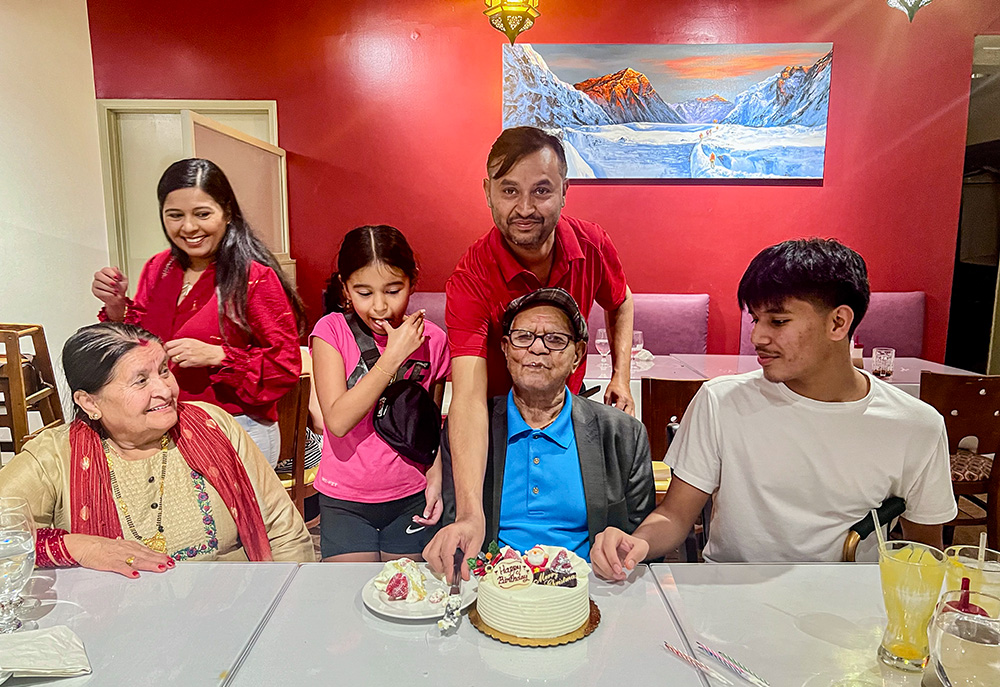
(591, 239, 958, 579)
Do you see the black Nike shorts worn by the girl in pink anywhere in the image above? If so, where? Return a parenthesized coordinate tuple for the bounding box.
(319, 491, 438, 558)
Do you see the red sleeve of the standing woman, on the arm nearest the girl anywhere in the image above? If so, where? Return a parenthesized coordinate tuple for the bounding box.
(211, 262, 302, 405)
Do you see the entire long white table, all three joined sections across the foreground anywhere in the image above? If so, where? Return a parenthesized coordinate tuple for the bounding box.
(11, 563, 952, 687)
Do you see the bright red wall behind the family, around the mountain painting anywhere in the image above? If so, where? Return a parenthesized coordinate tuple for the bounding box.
(88, 0, 1000, 360)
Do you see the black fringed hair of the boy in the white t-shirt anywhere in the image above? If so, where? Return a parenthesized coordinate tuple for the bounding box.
(736, 238, 871, 336)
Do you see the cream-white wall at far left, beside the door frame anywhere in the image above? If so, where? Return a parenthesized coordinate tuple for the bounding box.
(0, 0, 108, 404)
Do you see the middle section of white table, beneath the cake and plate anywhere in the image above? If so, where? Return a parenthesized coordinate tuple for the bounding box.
(224, 563, 705, 687)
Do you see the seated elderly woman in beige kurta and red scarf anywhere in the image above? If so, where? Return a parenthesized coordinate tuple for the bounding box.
(0, 322, 314, 577)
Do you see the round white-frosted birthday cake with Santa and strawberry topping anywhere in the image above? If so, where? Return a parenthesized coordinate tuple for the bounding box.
(470, 544, 590, 639)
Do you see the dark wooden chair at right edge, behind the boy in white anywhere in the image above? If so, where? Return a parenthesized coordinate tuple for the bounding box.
(920, 371, 1000, 549)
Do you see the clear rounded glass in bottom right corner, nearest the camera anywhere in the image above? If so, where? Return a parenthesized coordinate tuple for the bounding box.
(927, 591, 1000, 687)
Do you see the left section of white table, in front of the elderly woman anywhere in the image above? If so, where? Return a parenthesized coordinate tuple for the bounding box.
(4, 562, 298, 687)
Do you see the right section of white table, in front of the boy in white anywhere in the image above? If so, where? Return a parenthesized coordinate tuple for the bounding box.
(650, 563, 924, 687)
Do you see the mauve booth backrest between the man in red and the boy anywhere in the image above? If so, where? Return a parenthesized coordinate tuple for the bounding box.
(587, 293, 708, 355)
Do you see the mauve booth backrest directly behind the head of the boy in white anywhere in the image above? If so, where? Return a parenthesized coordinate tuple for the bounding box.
(740, 291, 926, 358)
